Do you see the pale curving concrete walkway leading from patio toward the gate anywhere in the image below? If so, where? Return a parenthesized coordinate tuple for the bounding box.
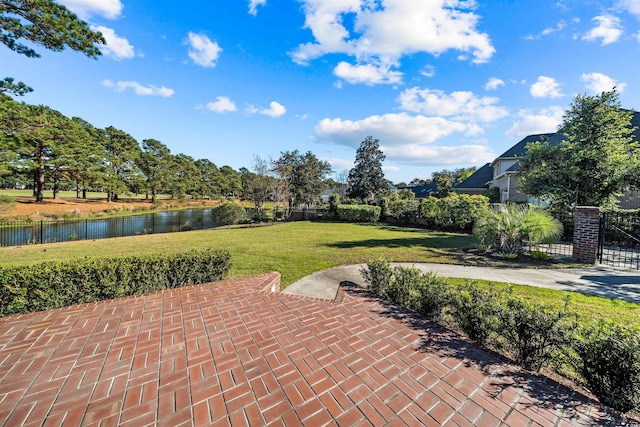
(282, 263, 640, 304)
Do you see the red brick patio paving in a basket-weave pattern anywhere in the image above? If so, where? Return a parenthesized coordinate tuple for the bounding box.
(0, 273, 616, 427)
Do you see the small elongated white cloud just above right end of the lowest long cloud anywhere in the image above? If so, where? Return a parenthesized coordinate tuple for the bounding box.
(397, 87, 509, 122)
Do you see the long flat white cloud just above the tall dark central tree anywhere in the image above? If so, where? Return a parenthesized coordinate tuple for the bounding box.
(315, 113, 482, 147)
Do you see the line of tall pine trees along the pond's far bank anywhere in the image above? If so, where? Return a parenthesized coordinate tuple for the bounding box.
(0, 94, 242, 202)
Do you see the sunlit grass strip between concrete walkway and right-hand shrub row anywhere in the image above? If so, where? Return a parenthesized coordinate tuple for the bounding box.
(447, 278, 640, 326)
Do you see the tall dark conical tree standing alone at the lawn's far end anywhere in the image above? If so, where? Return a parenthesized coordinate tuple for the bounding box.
(349, 136, 387, 201)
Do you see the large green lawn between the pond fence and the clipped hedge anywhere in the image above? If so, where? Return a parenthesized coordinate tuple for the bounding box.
(0, 222, 472, 286)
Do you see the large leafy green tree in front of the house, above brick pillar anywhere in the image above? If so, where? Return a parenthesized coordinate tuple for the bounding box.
(520, 88, 640, 209)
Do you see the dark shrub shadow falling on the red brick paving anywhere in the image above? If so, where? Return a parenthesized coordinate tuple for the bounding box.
(341, 282, 626, 426)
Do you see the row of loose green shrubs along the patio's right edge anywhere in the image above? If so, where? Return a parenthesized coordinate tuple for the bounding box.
(361, 260, 640, 412)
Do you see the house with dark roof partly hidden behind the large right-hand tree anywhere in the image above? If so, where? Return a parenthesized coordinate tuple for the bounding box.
(453, 111, 640, 209)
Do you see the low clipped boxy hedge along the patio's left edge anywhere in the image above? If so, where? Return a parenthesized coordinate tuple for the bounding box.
(0, 249, 231, 316)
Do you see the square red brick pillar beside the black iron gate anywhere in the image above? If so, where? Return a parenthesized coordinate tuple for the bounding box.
(573, 206, 600, 264)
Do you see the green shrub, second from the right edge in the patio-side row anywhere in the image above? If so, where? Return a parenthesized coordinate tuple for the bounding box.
(496, 294, 576, 371)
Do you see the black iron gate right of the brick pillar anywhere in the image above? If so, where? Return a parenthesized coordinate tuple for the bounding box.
(598, 210, 640, 270)
